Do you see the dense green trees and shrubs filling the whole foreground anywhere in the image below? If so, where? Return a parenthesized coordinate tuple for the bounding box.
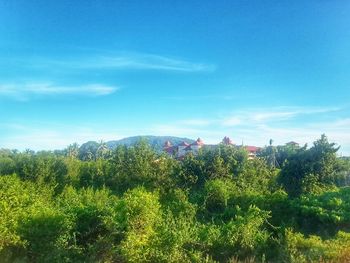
(0, 135, 350, 262)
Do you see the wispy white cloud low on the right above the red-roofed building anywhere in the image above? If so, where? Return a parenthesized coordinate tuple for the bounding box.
(147, 107, 350, 155)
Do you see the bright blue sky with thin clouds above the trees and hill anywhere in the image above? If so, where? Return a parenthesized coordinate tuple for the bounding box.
(0, 0, 350, 155)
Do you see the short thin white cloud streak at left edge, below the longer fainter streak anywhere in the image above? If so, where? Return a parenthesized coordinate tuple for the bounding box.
(0, 83, 119, 100)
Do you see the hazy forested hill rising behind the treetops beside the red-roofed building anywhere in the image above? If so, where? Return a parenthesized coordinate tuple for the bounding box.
(107, 135, 195, 151)
